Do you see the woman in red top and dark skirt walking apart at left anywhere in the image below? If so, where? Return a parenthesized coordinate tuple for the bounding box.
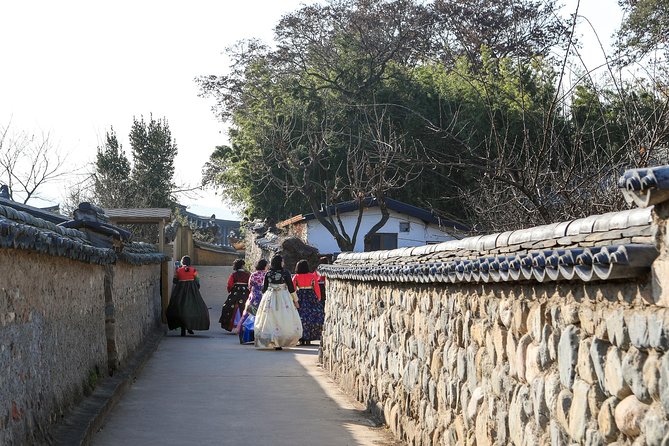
(165, 256, 209, 336)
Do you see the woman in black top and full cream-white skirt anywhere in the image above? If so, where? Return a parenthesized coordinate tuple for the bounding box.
(254, 255, 302, 350)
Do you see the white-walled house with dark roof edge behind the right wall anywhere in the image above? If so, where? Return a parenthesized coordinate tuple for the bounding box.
(277, 198, 467, 254)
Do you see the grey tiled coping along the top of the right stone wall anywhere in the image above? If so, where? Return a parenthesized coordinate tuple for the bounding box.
(319, 208, 658, 283)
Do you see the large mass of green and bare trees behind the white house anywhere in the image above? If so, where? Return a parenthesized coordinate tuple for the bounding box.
(199, 0, 669, 235)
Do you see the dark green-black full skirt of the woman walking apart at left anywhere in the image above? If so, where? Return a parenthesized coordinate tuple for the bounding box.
(165, 280, 209, 330)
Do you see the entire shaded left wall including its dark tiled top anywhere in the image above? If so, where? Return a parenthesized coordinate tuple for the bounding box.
(0, 206, 165, 445)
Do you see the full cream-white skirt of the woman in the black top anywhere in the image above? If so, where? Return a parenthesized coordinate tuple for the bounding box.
(254, 285, 302, 348)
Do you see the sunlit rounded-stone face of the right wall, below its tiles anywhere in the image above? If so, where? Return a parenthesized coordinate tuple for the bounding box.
(323, 279, 669, 446)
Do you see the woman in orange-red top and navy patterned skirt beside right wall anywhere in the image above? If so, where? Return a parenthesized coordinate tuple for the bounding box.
(293, 260, 325, 345)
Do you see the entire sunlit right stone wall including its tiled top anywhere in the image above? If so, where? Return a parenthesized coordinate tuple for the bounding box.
(320, 200, 669, 446)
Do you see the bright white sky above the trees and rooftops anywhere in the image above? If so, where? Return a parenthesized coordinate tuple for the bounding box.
(0, 0, 620, 219)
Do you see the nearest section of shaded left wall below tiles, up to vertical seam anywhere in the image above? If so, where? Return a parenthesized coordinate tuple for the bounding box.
(0, 249, 107, 444)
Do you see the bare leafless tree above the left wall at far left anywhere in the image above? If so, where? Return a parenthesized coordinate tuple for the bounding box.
(0, 124, 68, 203)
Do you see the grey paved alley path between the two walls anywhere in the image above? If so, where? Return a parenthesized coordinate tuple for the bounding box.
(92, 267, 397, 446)
